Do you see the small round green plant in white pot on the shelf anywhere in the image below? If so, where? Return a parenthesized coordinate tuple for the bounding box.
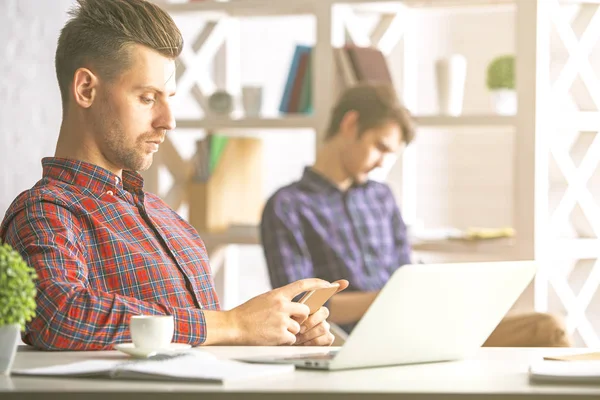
(487, 55, 517, 115)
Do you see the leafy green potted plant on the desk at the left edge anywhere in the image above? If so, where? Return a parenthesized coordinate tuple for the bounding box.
(0, 243, 37, 375)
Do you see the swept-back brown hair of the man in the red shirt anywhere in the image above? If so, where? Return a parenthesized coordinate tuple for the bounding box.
(55, 0, 183, 112)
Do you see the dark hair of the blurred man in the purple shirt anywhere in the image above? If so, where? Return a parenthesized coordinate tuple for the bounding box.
(325, 84, 415, 144)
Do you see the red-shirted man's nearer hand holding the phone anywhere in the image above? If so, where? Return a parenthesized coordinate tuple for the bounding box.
(216, 278, 338, 346)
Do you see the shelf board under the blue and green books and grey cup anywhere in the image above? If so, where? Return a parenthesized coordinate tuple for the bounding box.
(177, 115, 317, 130)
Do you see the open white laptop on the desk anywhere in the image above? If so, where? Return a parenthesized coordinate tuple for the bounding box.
(239, 261, 537, 371)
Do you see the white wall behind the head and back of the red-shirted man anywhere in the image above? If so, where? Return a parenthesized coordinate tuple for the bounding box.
(0, 0, 72, 216)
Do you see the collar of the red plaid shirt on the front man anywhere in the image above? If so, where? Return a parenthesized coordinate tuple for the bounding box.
(42, 157, 144, 195)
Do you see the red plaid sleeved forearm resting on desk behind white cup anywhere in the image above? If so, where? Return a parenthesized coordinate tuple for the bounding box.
(26, 284, 207, 350)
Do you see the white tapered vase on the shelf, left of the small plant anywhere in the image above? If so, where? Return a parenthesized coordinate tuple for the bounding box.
(435, 54, 467, 116)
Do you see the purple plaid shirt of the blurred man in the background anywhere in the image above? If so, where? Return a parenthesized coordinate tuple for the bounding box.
(261, 168, 410, 298)
